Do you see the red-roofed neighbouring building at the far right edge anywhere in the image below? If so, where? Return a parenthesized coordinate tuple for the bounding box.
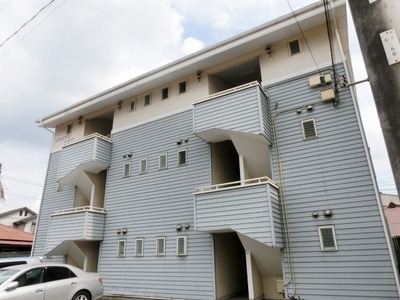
(380, 193, 400, 271)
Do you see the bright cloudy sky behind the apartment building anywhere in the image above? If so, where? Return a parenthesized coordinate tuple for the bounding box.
(0, 0, 396, 212)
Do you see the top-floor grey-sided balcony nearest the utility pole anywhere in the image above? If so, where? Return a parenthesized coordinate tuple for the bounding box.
(193, 81, 272, 144)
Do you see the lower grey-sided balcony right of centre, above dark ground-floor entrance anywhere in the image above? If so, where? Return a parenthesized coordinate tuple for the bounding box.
(194, 177, 283, 248)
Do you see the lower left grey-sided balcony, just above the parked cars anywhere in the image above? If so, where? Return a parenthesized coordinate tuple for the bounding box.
(47, 206, 106, 250)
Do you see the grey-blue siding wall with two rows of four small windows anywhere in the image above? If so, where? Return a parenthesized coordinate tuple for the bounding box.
(99, 110, 214, 299)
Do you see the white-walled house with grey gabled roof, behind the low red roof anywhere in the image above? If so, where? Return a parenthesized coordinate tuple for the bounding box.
(0, 207, 37, 233)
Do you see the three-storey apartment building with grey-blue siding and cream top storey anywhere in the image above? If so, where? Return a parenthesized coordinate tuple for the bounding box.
(33, 0, 399, 300)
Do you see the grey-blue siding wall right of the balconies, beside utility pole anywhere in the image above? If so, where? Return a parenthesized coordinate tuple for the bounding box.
(267, 66, 398, 300)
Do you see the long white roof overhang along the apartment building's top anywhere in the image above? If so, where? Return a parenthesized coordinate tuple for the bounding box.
(36, 0, 346, 128)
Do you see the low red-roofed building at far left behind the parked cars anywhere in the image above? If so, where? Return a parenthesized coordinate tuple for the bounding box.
(0, 224, 34, 258)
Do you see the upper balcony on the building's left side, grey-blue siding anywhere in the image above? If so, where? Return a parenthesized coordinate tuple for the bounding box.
(57, 133, 111, 185)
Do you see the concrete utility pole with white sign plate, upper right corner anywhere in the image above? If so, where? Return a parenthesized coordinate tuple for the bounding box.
(348, 0, 400, 195)
